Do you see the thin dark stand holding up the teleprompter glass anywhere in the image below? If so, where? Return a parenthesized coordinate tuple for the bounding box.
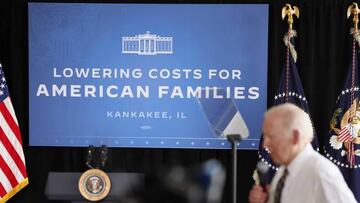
(226, 134, 241, 203)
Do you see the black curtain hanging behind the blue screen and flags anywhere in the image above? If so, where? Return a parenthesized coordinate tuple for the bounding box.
(0, 0, 358, 203)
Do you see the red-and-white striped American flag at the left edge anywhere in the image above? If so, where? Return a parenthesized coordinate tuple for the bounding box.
(0, 64, 28, 202)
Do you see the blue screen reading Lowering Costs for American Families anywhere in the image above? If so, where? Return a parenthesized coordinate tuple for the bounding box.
(28, 3, 268, 149)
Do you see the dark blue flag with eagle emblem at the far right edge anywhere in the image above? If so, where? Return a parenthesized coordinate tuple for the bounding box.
(324, 5, 360, 198)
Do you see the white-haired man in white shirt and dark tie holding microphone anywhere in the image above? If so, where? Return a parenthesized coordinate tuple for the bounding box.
(249, 103, 357, 203)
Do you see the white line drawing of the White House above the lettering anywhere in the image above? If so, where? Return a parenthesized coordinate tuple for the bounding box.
(122, 31, 173, 55)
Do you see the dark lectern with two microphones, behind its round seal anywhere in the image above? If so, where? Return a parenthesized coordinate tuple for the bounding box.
(45, 172, 144, 203)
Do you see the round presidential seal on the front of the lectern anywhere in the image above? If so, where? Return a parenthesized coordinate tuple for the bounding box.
(79, 169, 111, 201)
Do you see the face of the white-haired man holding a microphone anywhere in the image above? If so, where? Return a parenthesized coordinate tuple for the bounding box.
(263, 116, 292, 165)
